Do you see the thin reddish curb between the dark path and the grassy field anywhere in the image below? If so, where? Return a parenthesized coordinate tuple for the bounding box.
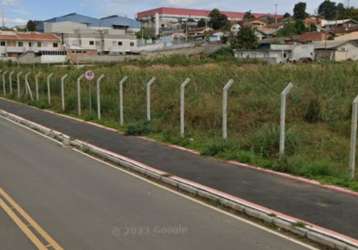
(0, 97, 358, 197)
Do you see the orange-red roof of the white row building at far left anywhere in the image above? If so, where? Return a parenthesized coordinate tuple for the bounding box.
(0, 32, 60, 42)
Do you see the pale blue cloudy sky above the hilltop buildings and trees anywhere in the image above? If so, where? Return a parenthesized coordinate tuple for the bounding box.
(0, 0, 358, 25)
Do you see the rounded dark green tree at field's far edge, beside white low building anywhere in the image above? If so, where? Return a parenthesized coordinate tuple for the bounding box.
(231, 26, 258, 49)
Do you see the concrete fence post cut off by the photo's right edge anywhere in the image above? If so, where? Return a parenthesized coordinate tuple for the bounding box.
(349, 96, 358, 179)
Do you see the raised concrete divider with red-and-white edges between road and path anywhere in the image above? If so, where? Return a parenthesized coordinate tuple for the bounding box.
(0, 110, 358, 250)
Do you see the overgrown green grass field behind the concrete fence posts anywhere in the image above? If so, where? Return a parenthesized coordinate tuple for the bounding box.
(3, 58, 358, 191)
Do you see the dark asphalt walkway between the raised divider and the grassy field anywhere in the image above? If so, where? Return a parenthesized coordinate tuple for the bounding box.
(0, 100, 358, 239)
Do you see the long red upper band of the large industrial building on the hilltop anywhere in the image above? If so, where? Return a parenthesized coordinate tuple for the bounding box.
(137, 7, 276, 20)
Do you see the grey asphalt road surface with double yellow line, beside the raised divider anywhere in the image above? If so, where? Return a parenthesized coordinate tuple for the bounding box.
(0, 119, 316, 250)
